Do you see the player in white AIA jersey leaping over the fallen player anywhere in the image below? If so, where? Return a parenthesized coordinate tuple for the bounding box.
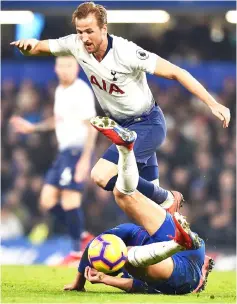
(11, 2, 230, 213)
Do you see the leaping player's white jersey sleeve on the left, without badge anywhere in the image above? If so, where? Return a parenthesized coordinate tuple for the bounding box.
(48, 34, 79, 56)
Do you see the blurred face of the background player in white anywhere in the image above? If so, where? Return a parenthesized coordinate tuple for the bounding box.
(55, 56, 79, 84)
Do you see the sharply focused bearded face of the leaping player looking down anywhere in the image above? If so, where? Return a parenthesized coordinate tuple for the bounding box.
(76, 14, 107, 54)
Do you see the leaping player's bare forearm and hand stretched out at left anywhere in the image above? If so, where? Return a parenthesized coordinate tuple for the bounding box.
(10, 39, 51, 56)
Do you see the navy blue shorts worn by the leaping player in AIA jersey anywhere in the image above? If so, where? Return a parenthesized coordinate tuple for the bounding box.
(102, 106, 166, 180)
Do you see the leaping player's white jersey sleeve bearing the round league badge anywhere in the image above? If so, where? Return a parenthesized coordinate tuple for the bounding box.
(115, 40, 159, 74)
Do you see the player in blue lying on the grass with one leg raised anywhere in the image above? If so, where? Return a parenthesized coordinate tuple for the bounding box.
(64, 118, 212, 294)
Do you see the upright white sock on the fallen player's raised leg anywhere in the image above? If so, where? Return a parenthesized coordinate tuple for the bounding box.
(115, 146, 139, 194)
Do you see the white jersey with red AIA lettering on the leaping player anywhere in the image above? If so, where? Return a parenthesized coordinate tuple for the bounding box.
(49, 34, 158, 121)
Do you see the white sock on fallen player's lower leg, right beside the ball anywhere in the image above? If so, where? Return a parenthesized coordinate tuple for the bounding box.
(128, 240, 185, 267)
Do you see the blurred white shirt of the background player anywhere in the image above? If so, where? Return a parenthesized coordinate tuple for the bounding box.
(54, 79, 96, 150)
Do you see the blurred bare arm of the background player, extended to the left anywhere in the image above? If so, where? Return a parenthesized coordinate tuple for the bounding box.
(10, 116, 55, 134)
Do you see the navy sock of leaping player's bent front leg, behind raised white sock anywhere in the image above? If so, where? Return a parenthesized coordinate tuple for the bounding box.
(104, 175, 168, 204)
